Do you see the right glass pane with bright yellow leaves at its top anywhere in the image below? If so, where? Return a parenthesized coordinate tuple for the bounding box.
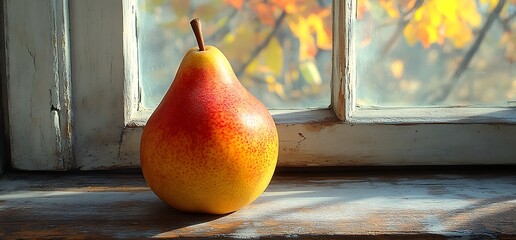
(354, 0, 516, 106)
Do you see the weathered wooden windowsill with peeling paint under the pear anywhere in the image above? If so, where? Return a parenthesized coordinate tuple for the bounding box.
(0, 171, 516, 239)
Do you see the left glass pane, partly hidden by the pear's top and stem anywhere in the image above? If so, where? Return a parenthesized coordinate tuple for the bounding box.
(137, 0, 332, 109)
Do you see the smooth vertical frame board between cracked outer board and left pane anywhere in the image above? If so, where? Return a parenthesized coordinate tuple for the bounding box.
(70, 0, 130, 170)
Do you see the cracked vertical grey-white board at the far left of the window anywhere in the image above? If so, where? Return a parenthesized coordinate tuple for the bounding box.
(2, 0, 73, 170)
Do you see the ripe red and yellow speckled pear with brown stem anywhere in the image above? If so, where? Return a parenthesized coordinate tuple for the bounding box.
(140, 18, 278, 214)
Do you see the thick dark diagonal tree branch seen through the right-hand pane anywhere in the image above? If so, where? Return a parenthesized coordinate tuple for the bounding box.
(430, 0, 506, 104)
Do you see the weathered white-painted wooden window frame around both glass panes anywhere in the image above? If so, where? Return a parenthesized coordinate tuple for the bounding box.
(5, 0, 516, 170)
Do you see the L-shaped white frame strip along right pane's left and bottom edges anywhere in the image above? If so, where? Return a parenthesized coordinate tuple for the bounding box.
(333, 0, 516, 124)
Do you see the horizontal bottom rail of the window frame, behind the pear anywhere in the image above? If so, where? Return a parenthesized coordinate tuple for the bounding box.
(120, 113, 516, 167)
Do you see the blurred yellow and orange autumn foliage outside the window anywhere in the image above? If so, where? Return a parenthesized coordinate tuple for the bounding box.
(138, 0, 516, 109)
